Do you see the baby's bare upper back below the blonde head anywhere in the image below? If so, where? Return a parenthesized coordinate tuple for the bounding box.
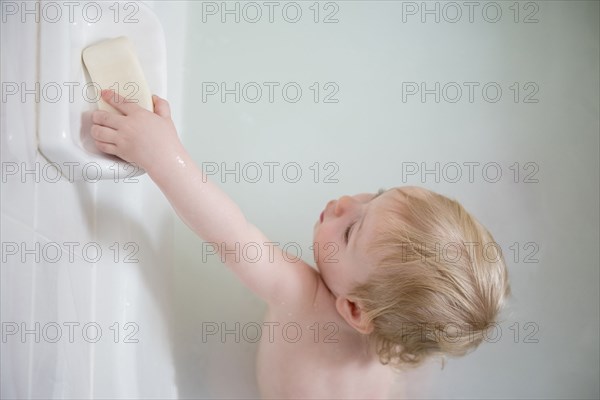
(257, 265, 393, 399)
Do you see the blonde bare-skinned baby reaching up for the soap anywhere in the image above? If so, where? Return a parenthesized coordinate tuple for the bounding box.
(91, 91, 509, 399)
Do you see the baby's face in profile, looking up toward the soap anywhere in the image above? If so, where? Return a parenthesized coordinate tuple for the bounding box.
(313, 190, 393, 296)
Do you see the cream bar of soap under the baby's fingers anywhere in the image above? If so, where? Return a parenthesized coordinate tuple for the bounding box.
(82, 36, 154, 115)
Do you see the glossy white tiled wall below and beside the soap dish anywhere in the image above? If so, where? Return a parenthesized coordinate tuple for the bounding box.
(0, 2, 182, 399)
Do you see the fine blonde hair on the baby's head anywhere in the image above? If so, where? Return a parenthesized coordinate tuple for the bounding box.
(350, 188, 510, 368)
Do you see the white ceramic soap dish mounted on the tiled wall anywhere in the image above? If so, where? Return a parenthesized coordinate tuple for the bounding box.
(37, 2, 167, 181)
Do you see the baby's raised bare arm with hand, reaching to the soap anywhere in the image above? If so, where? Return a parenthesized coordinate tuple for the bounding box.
(91, 91, 317, 304)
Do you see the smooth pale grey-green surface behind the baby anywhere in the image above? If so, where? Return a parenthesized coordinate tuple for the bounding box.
(175, 1, 599, 398)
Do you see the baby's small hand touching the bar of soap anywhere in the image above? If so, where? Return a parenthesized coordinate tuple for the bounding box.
(91, 90, 181, 171)
